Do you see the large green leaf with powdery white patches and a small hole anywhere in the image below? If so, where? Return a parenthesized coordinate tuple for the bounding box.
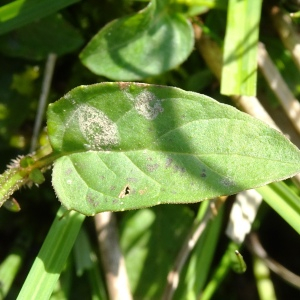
(48, 83, 300, 215)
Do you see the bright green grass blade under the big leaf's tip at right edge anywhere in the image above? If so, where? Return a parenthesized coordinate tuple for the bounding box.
(257, 182, 300, 234)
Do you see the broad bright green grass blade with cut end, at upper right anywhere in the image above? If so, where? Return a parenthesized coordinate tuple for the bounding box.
(221, 0, 262, 96)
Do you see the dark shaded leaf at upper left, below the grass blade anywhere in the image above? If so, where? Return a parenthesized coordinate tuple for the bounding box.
(0, 14, 83, 60)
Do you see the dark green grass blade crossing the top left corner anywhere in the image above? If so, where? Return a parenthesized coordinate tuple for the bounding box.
(0, 0, 79, 34)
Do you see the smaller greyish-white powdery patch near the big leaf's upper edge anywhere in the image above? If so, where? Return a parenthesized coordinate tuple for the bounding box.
(134, 91, 164, 120)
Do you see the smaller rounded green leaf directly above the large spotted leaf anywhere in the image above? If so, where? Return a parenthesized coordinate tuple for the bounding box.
(80, 0, 194, 80)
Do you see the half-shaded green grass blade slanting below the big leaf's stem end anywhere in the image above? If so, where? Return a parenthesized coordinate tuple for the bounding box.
(17, 208, 85, 300)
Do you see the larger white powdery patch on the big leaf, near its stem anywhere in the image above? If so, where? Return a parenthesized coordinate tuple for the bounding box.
(77, 104, 119, 150)
